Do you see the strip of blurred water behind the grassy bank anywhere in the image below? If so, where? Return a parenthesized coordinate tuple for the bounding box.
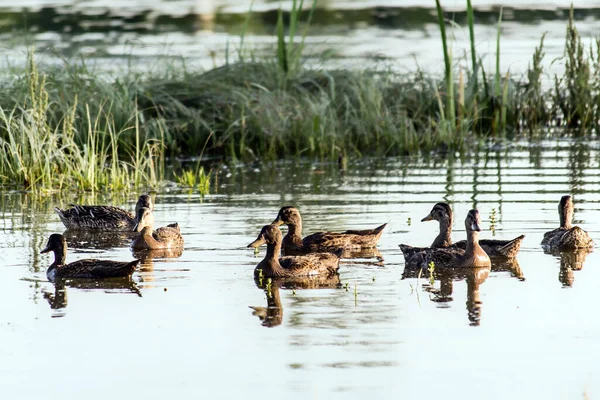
(0, 0, 600, 76)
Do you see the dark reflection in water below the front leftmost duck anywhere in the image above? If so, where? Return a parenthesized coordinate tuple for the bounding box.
(44, 277, 142, 310)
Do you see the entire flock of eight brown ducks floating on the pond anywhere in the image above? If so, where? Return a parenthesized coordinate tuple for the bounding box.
(42, 194, 594, 281)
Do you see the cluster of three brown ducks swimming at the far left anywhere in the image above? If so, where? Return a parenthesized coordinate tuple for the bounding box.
(41, 194, 184, 281)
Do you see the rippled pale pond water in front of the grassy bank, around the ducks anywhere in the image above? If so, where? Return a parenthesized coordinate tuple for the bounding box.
(0, 141, 600, 399)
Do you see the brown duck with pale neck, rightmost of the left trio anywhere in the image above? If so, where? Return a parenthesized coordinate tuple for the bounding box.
(131, 207, 183, 250)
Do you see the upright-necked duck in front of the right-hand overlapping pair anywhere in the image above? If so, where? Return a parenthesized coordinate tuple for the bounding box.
(400, 209, 492, 268)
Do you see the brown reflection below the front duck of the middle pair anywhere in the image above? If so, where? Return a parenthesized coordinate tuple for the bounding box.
(249, 274, 341, 328)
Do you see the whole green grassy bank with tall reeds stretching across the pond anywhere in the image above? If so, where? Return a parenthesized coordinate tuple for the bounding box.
(0, 0, 600, 193)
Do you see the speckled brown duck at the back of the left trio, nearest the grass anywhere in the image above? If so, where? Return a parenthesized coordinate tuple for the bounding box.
(54, 194, 154, 232)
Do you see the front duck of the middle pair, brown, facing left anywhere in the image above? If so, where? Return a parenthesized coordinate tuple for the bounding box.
(248, 225, 343, 278)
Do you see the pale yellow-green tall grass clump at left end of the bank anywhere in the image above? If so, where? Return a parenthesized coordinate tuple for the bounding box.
(0, 54, 163, 191)
